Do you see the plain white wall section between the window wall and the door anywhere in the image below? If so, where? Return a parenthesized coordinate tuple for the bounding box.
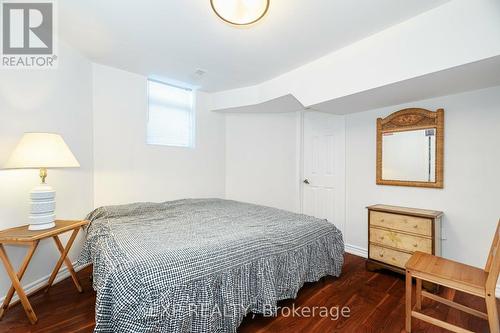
(226, 113, 300, 211)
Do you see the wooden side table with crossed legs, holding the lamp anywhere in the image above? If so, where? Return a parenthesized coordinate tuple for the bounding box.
(0, 221, 89, 324)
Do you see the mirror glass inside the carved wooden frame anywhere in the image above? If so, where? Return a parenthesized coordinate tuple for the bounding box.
(382, 128, 436, 182)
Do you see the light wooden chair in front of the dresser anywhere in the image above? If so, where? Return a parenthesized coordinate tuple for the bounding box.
(406, 221, 500, 333)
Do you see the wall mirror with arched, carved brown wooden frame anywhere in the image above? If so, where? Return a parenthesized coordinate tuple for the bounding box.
(377, 108, 444, 188)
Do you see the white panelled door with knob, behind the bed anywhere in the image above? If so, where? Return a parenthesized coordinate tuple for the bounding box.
(301, 111, 345, 232)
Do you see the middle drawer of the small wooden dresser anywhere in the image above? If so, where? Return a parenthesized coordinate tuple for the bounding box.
(370, 228, 432, 254)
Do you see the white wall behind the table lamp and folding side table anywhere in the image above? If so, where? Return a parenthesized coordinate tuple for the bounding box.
(0, 43, 93, 296)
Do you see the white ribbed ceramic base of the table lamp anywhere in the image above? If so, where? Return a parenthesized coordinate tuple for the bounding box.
(28, 184, 56, 230)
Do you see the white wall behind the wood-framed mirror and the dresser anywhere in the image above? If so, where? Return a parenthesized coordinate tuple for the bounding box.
(344, 87, 500, 266)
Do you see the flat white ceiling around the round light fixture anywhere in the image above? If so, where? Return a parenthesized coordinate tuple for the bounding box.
(58, 0, 448, 92)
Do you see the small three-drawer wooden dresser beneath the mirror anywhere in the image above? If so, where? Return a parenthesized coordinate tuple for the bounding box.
(366, 205, 443, 274)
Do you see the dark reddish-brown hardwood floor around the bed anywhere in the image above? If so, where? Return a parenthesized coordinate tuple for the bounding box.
(0, 254, 489, 333)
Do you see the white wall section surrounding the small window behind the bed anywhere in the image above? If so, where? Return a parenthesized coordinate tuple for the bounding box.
(93, 64, 225, 207)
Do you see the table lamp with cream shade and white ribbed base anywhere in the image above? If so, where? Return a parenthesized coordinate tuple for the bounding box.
(4, 133, 80, 230)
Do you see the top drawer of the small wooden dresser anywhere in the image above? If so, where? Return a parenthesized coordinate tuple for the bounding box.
(370, 211, 432, 237)
